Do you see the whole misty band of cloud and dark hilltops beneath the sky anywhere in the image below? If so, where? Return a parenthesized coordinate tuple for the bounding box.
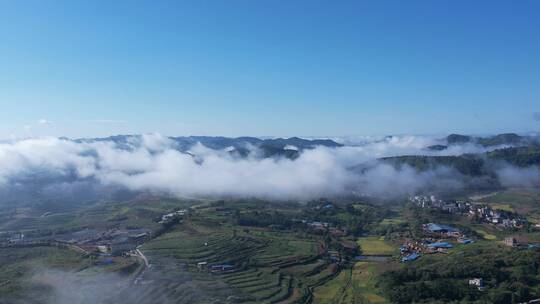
(0, 134, 540, 201)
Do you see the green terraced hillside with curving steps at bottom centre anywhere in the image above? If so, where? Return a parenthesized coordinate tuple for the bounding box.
(138, 221, 337, 303)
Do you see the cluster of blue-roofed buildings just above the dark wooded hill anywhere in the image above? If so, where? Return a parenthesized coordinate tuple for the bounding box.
(400, 223, 474, 262)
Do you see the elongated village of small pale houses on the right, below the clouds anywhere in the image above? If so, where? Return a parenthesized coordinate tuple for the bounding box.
(409, 195, 527, 228)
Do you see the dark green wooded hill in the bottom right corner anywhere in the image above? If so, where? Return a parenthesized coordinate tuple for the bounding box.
(380, 243, 540, 303)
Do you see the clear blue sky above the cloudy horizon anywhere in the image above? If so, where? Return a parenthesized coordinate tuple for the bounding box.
(0, 0, 540, 138)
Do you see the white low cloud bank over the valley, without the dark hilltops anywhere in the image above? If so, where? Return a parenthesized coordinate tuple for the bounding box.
(0, 134, 540, 199)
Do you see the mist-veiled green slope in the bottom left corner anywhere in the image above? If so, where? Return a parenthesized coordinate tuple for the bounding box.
(0, 246, 138, 304)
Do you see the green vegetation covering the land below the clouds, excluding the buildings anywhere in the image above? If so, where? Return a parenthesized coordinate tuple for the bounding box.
(0, 185, 540, 304)
